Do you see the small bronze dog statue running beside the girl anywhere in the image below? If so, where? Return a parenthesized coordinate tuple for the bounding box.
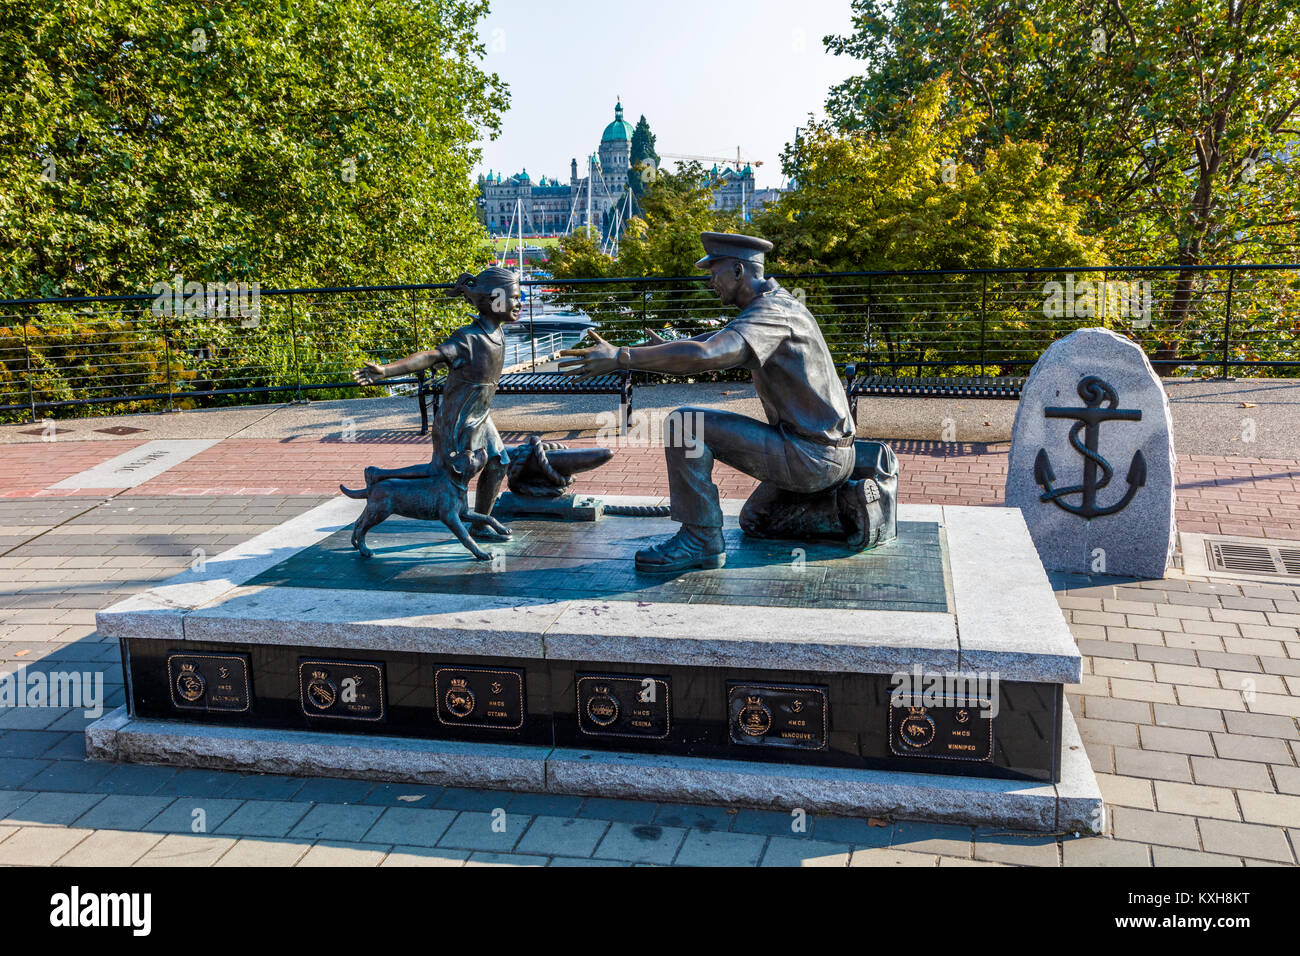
(338, 449, 510, 561)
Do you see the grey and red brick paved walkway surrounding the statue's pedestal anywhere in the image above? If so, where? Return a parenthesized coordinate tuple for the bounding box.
(0, 437, 1300, 866)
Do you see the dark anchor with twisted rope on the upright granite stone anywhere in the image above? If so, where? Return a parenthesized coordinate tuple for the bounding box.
(1034, 375, 1147, 519)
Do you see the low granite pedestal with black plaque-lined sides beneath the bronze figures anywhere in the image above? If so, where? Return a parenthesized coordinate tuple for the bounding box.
(86, 498, 1101, 831)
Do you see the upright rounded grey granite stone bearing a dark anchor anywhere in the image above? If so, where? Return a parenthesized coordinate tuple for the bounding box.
(1006, 329, 1175, 578)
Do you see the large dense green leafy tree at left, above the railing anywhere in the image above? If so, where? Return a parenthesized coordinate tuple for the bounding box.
(0, 0, 507, 297)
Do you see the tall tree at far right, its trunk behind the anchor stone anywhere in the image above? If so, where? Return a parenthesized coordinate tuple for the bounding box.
(827, 0, 1300, 358)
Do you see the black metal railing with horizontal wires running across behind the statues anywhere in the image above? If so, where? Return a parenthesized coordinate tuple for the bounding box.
(0, 264, 1300, 420)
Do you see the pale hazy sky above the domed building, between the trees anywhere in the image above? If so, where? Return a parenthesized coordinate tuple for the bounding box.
(476, 0, 862, 189)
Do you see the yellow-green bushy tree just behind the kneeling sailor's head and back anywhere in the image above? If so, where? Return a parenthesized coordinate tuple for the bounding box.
(754, 79, 1102, 375)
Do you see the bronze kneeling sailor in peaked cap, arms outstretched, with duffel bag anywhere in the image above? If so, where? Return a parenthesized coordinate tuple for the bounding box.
(560, 233, 897, 574)
